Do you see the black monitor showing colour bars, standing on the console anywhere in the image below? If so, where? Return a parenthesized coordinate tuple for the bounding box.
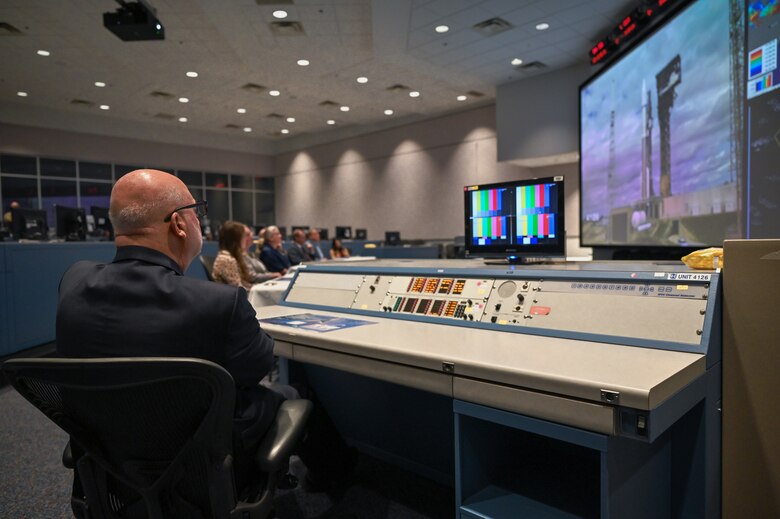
(463, 176, 566, 263)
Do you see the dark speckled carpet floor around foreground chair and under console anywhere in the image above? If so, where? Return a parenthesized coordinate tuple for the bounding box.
(0, 386, 455, 519)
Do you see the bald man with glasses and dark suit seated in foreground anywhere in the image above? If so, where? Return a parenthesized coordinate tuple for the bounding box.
(57, 170, 283, 488)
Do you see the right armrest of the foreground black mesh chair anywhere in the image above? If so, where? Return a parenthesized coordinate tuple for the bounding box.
(255, 399, 314, 472)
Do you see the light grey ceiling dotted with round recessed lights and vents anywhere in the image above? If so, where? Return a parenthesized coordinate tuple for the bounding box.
(0, 0, 637, 153)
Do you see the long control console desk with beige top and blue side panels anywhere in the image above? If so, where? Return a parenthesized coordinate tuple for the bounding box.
(257, 260, 721, 518)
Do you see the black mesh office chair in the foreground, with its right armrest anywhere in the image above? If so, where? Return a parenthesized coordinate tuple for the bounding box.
(3, 357, 312, 519)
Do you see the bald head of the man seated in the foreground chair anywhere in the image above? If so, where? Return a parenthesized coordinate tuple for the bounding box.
(109, 169, 202, 270)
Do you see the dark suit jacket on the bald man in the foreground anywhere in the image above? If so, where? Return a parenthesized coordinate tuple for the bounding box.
(57, 247, 281, 446)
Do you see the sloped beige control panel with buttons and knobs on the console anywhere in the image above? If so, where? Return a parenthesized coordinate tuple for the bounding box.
(288, 271, 710, 344)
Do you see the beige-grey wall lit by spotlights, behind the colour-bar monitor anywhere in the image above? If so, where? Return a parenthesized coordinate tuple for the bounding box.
(274, 106, 579, 250)
